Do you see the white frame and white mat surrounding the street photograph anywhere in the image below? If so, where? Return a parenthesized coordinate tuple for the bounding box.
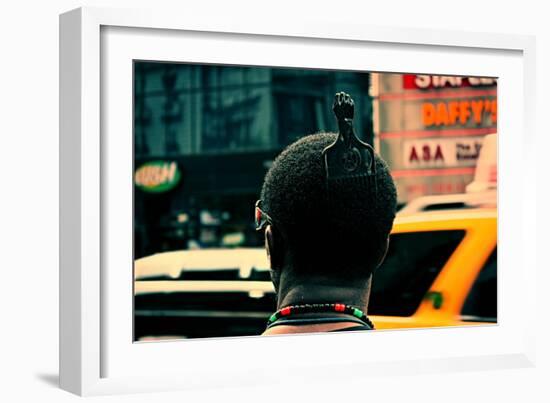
(60, 8, 537, 395)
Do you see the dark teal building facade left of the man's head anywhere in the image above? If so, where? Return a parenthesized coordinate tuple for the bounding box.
(134, 62, 373, 258)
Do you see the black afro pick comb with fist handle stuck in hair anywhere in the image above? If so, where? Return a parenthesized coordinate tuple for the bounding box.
(323, 92, 376, 207)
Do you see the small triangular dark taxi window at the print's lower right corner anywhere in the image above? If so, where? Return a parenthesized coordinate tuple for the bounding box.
(461, 248, 497, 322)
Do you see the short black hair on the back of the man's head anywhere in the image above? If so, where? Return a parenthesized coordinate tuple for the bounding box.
(261, 133, 397, 280)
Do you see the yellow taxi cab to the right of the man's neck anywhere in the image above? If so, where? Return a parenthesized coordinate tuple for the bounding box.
(369, 209, 497, 329)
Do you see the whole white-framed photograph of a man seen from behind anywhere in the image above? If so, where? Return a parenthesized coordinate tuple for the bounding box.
(60, 8, 536, 395)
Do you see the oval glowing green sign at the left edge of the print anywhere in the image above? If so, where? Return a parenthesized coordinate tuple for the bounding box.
(134, 161, 181, 193)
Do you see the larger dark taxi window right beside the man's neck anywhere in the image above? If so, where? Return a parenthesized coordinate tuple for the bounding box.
(368, 230, 465, 316)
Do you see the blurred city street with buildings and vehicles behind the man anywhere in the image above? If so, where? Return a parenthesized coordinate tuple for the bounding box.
(134, 61, 497, 341)
